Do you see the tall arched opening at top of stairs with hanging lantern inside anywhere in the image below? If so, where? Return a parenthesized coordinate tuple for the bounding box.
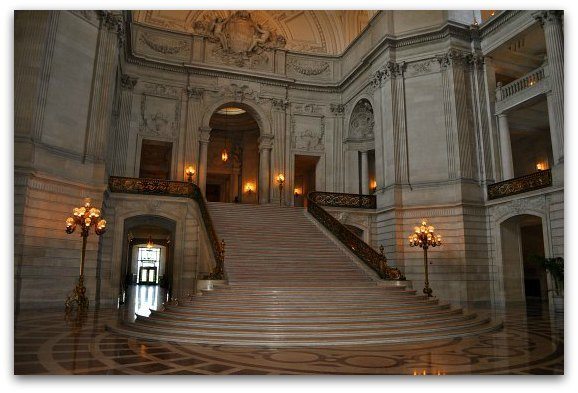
(205, 103, 260, 203)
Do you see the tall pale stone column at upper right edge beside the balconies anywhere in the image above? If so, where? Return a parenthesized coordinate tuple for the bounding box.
(534, 11, 564, 165)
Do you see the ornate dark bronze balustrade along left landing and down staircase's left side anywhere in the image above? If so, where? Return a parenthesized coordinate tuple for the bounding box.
(108, 176, 225, 280)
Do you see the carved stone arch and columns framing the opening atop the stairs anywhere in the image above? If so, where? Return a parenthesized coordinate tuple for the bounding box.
(198, 98, 273, 204)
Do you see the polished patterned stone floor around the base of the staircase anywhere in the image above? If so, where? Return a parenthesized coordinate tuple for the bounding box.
(14, 286, 564, 375)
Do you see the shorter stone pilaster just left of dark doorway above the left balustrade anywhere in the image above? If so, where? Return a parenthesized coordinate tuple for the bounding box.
(111, 75, 138, 176)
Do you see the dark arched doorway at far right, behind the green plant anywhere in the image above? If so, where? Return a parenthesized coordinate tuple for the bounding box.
(500, 214, 548, 305)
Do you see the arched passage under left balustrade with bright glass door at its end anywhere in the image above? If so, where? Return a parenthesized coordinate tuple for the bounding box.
(121, 215, 176, 315)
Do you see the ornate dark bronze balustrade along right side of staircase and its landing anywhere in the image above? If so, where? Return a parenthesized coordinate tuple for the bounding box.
(307, 192, 405, 280)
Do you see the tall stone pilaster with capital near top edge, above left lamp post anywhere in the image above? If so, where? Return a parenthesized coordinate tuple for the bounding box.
(83, 11, 122, 161)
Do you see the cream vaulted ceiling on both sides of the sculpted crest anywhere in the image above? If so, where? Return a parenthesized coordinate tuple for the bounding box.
(132, 10, 377, 54)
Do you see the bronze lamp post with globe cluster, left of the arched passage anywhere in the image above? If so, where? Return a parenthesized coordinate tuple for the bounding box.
(64, 198, 106, 313)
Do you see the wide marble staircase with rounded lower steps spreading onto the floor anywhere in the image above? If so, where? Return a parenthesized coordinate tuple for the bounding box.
(109, 203, 500, 347)
